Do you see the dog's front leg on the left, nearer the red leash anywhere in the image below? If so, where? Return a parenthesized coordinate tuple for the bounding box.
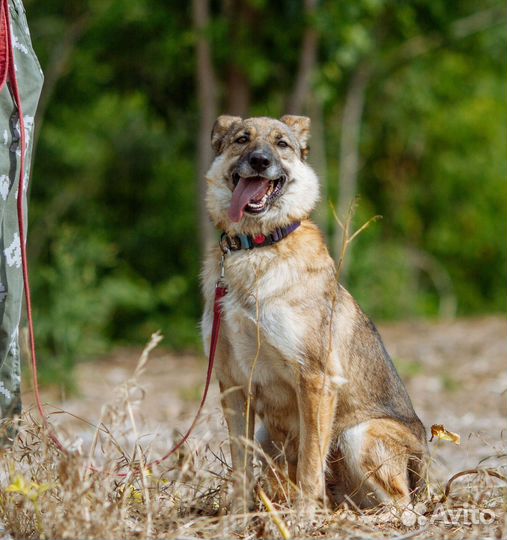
(220, 377, 255, 512)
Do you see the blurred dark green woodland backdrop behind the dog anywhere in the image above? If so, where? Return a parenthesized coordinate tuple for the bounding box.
(25, 0, 507, 385)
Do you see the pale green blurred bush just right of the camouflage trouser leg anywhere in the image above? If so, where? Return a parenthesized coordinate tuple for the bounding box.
(33, 227, 114, 389)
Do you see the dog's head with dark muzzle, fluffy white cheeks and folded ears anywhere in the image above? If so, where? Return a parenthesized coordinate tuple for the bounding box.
(206, 115, 319, 234)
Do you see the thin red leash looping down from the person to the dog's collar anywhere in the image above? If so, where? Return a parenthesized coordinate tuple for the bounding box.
(0, 0, 227, 477)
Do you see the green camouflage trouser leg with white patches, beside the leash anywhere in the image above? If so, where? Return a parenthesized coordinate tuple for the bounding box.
(0, 0, 43, 445)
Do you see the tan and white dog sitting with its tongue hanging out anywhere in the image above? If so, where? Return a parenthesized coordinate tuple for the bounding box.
(202, 115, 427, 507)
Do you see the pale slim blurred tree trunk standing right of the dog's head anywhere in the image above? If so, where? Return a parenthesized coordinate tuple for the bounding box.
(334, 63, 371, 280)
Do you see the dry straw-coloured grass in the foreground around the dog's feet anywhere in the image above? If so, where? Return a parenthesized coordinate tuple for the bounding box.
(0, 337, 507, 540)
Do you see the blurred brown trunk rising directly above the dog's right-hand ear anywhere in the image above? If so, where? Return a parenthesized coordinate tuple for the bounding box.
(286, 0, 319, 114)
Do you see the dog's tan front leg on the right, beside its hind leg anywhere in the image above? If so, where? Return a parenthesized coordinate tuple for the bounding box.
(297, 373, 336, 500)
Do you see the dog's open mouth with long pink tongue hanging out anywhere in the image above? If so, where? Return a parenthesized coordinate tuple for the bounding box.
(229, 173, 286, 222)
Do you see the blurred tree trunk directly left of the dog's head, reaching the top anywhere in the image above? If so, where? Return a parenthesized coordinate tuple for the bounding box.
(192, 0, 217, 252)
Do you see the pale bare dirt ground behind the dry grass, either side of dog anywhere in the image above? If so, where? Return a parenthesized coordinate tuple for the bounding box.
(4, 317, 507, 538)
